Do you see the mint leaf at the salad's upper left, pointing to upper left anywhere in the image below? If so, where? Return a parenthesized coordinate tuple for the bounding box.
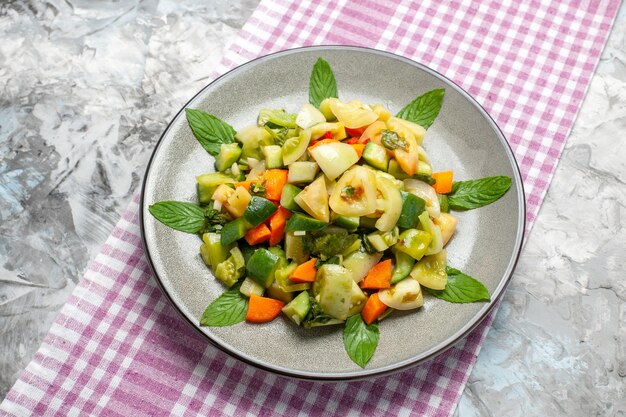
(185, 109, 237, 156)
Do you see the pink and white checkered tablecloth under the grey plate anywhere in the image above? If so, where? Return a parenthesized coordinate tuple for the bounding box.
(0, 0, 619, 416)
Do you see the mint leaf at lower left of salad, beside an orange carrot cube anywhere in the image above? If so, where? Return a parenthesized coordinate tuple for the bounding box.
(200, 282, 248, 327)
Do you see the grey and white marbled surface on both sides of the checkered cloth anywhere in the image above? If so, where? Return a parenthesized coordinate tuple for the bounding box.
(0, 0, 626, 417)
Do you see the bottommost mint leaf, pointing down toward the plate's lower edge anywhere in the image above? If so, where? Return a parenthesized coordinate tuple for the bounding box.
(343, 314, 379, 368)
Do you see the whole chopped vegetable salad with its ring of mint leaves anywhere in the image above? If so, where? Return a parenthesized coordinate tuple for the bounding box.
(149, 58, 511, 367)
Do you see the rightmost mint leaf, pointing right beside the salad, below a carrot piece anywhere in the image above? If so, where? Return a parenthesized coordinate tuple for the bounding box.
(447, 175, 511, 210)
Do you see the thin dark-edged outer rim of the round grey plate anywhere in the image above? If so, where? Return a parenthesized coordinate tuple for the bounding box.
(139, 45, 527, 382)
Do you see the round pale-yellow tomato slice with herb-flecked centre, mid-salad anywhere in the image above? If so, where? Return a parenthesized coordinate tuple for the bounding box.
(329, 165, 376, 216)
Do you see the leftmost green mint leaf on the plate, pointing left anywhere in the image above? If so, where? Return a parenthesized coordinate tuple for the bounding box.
(148, 201, 205, 233)
